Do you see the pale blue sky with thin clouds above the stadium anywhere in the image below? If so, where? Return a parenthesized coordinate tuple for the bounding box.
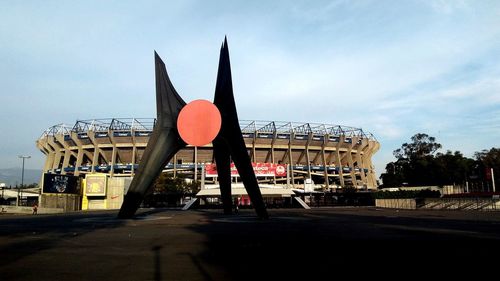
(0, 0, 500, 176)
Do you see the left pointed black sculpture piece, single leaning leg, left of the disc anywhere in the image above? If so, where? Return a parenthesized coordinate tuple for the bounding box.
(118, 52, 186, 218)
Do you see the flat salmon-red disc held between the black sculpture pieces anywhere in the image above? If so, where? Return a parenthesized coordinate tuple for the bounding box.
(177, 100, 222, 146)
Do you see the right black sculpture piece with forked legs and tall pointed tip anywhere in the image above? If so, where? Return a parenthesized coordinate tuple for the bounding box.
(213, 38, 268, 219)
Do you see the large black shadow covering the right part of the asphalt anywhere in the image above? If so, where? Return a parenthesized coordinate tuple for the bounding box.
(184, 210, 500, 280)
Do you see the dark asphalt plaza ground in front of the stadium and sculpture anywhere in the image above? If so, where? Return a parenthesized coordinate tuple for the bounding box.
(0, 207, 500, 280)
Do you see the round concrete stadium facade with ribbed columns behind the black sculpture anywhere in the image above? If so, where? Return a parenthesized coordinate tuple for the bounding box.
(36, 118, 380, 190)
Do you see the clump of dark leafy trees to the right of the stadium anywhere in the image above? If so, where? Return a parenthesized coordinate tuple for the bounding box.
(380, 133, 500, 190)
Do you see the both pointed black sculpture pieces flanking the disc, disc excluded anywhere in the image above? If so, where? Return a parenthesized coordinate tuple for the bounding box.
(118, 38, 268, 219)
